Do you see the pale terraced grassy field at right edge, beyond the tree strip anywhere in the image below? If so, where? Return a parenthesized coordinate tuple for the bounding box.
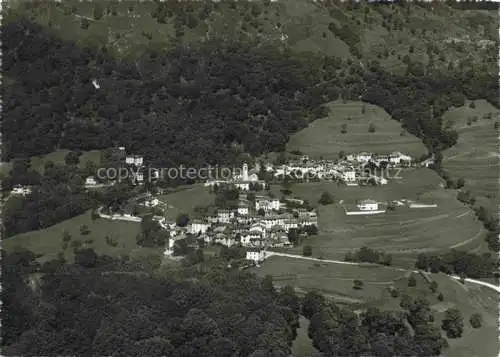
(442, 100, 500, 211)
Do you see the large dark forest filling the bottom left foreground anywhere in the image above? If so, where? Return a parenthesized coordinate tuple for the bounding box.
(2, 251, 298, 357)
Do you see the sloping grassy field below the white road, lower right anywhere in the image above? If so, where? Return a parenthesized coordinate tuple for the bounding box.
(255, 257, 500, 357)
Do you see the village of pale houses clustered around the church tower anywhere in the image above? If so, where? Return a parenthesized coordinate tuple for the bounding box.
(12, 147, 435, 263)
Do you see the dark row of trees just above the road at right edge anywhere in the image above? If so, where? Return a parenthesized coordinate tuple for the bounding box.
(415, 249, 498, 279)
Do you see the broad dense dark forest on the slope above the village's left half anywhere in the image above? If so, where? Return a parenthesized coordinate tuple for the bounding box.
(2, 18, 320, 167)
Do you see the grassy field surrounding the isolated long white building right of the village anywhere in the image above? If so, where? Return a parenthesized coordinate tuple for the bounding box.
(274, 169, 484, 266)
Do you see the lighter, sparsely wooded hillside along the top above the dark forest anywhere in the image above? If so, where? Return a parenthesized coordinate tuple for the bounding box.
(12, 0, 498, 73)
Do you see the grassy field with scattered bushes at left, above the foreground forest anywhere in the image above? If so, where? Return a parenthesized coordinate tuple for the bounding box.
(2, 207, 148, 262)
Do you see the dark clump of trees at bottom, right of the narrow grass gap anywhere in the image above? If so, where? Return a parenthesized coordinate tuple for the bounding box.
(303, 292, 448, 357)
